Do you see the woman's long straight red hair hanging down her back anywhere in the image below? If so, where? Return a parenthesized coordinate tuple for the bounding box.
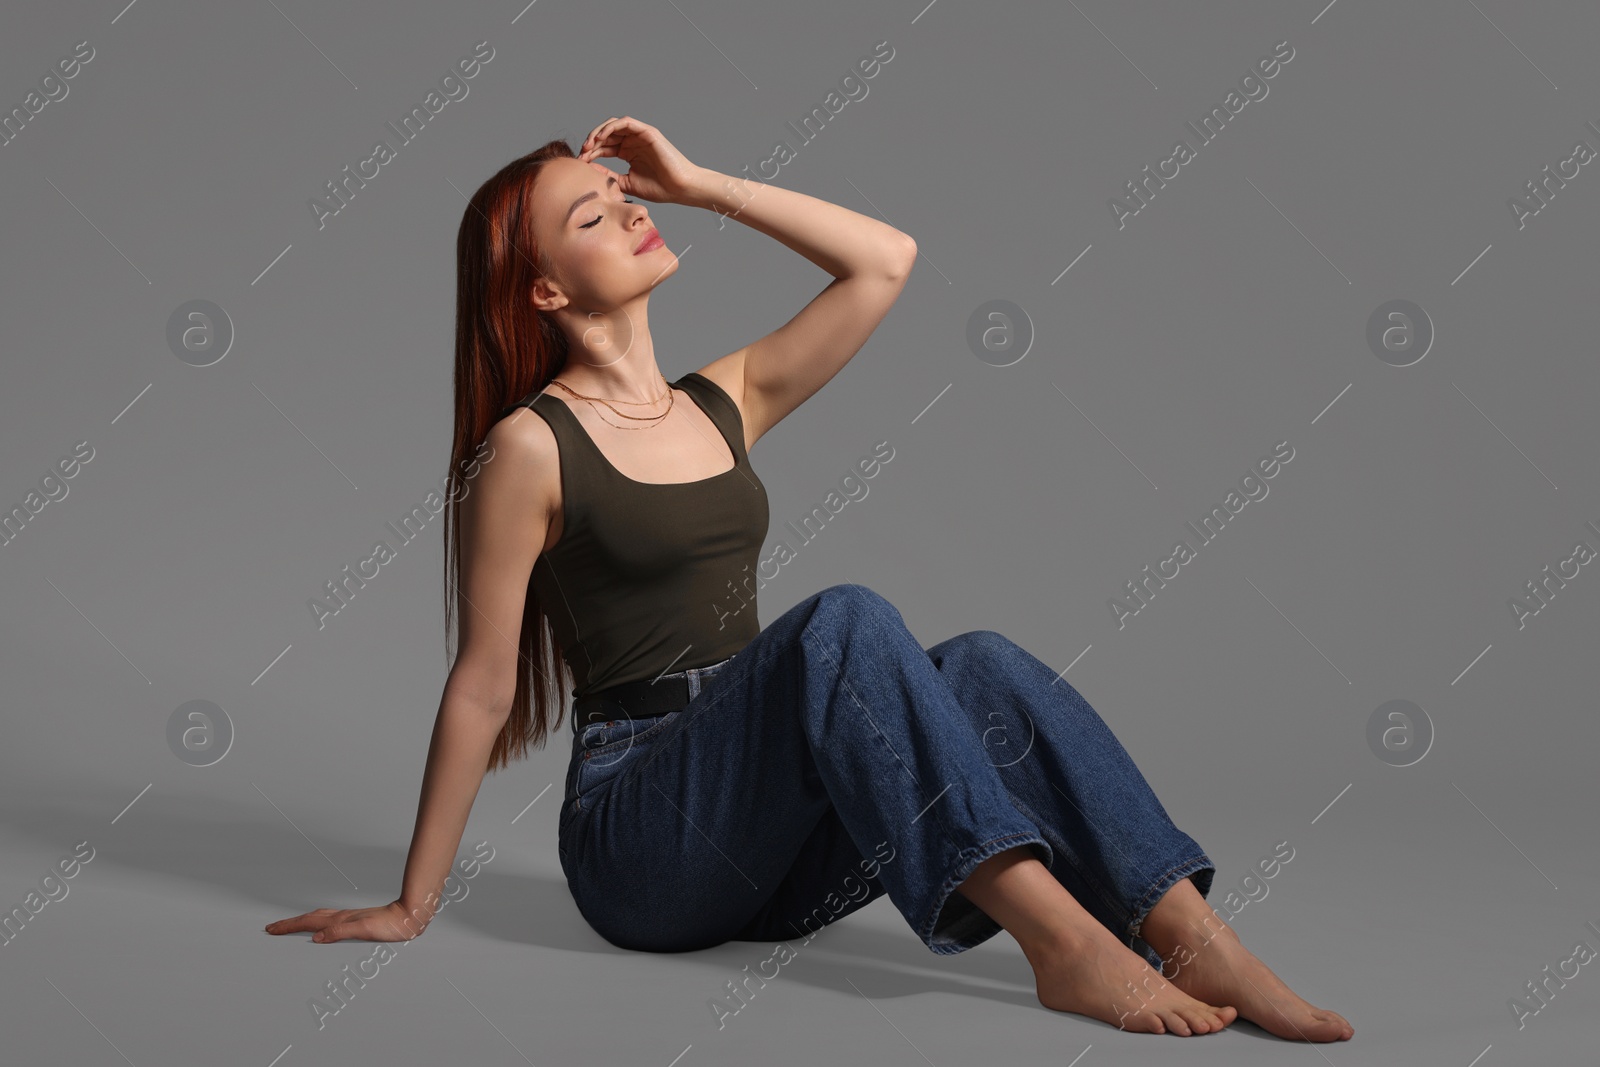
(445, 141, 576, 771)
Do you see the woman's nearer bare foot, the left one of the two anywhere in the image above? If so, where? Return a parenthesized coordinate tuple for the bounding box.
(1024, 928, 1238, 1037)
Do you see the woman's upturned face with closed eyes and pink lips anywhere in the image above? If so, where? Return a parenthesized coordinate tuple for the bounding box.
(533, 158, 677, 312)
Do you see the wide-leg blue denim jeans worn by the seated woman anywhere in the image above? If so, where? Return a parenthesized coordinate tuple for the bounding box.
(558, 584, 1216, 968)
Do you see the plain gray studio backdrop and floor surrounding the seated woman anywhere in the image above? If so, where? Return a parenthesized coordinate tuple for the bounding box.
(0, 0, 1600, 1067)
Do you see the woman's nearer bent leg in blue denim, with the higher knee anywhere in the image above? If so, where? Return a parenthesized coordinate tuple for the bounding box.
(566, 584, 1051, 955)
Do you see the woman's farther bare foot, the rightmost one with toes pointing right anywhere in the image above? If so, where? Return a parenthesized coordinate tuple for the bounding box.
(1163, 926, 1355, 1041)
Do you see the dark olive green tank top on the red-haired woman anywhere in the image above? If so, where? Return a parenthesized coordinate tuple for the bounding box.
(501, 371, 770, 699)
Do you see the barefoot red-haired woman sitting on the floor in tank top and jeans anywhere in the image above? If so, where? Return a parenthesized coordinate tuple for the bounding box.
(267, 117, 1354, 1041)
